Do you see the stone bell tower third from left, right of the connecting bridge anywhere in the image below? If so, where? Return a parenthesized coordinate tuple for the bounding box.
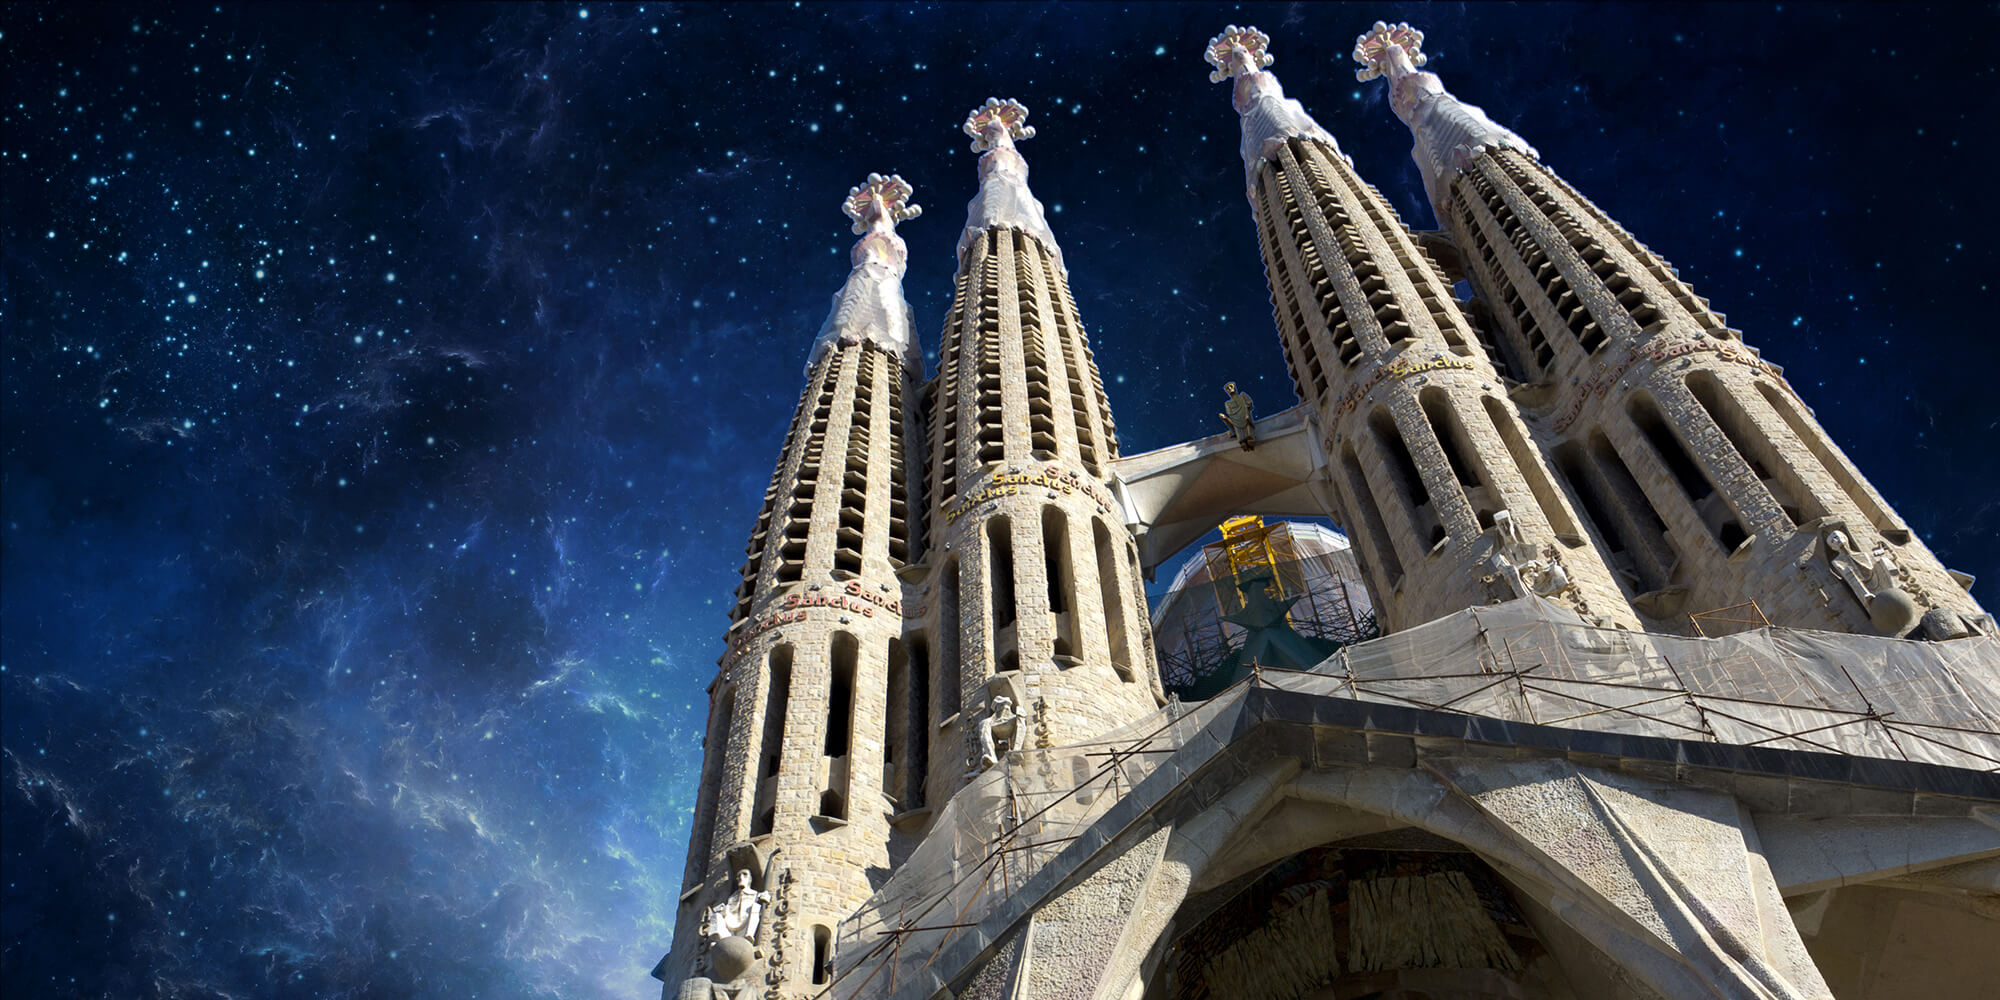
(1206, 26, 1638, 630)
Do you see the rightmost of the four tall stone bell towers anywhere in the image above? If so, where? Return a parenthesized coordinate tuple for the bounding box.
(1354, 22, 1986, 638)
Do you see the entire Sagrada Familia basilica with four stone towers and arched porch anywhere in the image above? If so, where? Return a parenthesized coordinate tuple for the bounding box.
(654, 24, 2000, 1000)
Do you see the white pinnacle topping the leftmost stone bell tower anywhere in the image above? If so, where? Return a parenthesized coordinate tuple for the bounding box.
(806, 174, 924, 376)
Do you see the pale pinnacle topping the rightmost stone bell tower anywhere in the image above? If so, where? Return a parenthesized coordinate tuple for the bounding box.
(1354, 20, 1542, 220)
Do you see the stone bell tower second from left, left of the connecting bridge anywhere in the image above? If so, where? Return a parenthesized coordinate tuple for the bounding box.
(920, 98, 1160, 802)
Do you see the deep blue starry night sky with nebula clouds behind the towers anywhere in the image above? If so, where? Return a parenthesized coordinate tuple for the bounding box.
(0, 2, 2000, 1000)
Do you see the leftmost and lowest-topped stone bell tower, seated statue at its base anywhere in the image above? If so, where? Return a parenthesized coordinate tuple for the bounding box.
(658, 174, 922, 996)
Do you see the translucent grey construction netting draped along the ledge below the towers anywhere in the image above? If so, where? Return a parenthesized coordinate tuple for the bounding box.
(820, 598, 2000, 998)
